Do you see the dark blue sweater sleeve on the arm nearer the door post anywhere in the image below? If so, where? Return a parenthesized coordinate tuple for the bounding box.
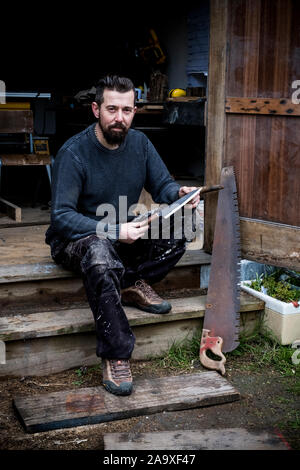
(145, 140, 180, 204)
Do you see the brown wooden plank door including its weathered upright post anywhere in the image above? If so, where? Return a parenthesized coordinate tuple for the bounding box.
(204, 0, 300, 270)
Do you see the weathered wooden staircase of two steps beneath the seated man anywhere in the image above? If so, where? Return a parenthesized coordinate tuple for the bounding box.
(0, 225, 264, 376)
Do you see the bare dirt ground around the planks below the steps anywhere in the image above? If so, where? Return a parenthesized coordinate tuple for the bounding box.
(0, 355, 300, 450)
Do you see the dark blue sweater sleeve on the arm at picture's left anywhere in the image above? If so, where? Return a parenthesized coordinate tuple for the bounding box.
(51, 149, 118, 240)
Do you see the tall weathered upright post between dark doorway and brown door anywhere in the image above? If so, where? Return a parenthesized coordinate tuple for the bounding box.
(204, 0, 228, 253)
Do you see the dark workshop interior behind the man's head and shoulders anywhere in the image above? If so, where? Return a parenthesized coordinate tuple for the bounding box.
(0, 0, 209, 221)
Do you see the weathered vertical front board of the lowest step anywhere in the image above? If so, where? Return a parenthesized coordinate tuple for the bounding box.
(0, 311, 262, 377)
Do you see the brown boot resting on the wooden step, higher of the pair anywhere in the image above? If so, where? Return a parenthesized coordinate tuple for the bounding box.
(121, 280, 172, 313)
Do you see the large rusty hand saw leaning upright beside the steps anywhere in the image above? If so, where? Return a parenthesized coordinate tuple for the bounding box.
(200, 166, 240, 375)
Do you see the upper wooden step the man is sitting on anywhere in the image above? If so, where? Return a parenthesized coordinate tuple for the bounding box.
(0, 232, 211, 316)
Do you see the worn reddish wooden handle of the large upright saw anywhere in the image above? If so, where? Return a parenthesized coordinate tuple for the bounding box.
(199, 329, 226, 375)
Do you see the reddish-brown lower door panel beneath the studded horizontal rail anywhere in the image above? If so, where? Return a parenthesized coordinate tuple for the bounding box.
(224, 114, 300, 226)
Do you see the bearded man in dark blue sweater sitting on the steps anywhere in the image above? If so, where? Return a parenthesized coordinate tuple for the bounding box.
(46, 76, 199, 395)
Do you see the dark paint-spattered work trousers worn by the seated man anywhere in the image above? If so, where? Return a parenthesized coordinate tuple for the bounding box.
(54, 235, 185, 359)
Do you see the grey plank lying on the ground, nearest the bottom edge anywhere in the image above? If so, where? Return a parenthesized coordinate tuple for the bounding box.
(104, 428, 289, 450)
